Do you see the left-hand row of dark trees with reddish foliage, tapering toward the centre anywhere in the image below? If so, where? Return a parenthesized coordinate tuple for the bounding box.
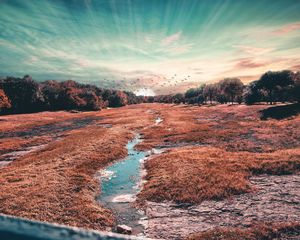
(0, 75, 144, 113)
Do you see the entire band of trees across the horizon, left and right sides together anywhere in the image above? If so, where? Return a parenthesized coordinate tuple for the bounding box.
(0, 70, 300, 113)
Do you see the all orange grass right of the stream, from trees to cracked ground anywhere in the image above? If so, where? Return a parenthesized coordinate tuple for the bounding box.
(139, 105, 300, 203)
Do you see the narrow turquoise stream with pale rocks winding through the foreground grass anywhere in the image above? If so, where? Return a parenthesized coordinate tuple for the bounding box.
(98, 135, 148, 234)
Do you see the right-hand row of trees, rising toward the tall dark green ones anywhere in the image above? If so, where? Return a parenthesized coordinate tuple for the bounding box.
(148, 70, 300, 105)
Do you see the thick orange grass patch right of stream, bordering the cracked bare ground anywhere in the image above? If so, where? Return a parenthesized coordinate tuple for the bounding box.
(139, 147, 300, 203)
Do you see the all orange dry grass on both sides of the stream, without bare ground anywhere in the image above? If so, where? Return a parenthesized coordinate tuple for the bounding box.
(0, 104, 300, 230)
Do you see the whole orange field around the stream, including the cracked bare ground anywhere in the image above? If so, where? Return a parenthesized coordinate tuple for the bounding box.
(0, 103, 300, 239)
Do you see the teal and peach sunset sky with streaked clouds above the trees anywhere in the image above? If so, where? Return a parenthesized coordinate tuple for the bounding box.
(0, 0, 300, 95)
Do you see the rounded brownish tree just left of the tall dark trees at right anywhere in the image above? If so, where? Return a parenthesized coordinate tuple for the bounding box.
(219, 78, 244, 104)
